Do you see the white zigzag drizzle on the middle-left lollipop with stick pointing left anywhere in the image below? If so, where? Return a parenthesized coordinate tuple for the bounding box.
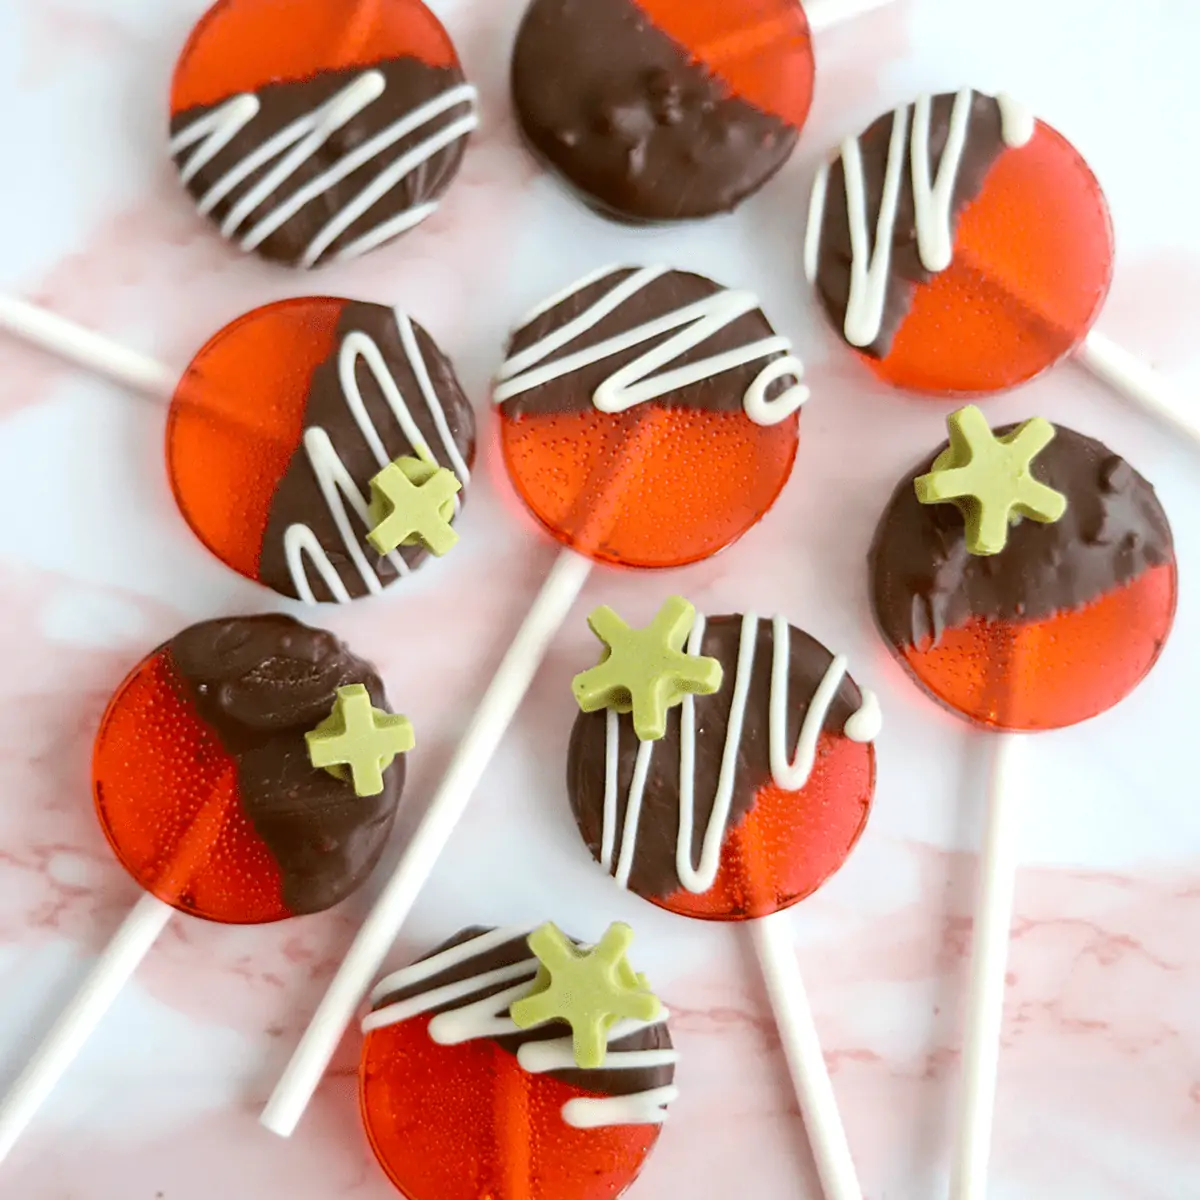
(283, 308, 470, 605)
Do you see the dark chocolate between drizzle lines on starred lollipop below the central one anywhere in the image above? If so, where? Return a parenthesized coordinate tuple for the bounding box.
(566, 617, 863, 900)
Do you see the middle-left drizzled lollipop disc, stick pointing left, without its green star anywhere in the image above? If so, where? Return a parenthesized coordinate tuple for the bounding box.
(167, 296, 475, 602)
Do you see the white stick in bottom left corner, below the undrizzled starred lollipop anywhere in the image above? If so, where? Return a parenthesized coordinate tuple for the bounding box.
(0, 892, 175, 1162)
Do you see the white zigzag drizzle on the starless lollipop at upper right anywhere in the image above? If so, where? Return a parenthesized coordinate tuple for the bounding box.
(804, 88, 1036, 346)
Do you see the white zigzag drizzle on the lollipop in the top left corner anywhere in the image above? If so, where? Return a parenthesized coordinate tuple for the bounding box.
(170, 71, 479, 268)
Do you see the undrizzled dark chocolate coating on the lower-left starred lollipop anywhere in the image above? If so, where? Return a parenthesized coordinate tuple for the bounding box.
(167, 616, 404, 916)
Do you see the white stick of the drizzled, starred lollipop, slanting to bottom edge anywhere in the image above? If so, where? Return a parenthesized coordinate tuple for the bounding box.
(749, 911, 863, 1200)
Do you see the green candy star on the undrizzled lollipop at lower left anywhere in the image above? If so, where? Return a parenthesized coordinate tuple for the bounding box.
(305, 683, 416, 796)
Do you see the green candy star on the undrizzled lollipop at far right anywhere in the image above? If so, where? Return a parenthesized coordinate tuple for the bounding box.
(916, 404, 1067, 556)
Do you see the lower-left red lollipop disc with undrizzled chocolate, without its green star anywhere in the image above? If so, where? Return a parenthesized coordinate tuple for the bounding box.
(92, 617, 404, 924)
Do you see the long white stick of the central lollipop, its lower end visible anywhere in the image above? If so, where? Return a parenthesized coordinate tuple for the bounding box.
(266, 550, 592, 1138)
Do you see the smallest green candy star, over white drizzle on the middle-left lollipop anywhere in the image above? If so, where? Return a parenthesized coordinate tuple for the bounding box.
(367, 458, 462, 556)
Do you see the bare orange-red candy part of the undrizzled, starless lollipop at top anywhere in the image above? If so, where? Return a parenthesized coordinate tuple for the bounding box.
(636, 0, 815, 128)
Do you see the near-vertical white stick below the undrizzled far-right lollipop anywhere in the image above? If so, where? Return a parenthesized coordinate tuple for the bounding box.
(950, 733, 1025, 1200)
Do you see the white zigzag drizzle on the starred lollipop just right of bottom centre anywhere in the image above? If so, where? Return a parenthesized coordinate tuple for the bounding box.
(600, 613, 881, 895)
